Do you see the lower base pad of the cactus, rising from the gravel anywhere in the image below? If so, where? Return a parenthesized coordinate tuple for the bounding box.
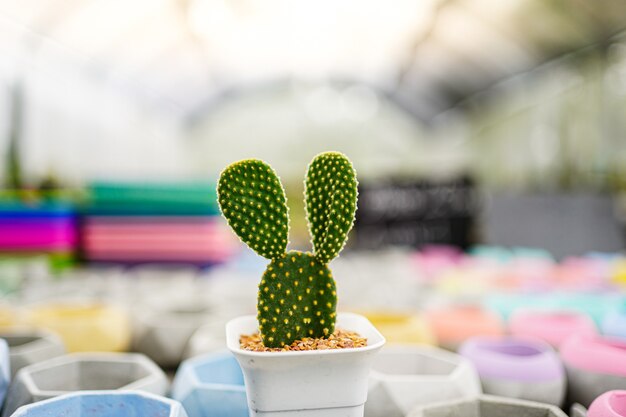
(257, 251, 337, 348)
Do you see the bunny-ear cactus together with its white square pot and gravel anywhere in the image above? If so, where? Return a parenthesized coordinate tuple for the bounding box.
(217, 152, 385, 417)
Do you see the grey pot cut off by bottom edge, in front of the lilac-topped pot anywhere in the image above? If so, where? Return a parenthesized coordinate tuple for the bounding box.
(407, 395, 567, 417)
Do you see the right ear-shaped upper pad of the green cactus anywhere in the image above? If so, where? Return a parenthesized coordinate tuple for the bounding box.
(304, 152, 357, 264)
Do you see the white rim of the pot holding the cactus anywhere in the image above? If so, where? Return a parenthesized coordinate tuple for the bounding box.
(226, 313, 386, 358)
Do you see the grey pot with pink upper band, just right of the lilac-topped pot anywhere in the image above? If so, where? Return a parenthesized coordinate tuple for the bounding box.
(561, 336, 626, 407)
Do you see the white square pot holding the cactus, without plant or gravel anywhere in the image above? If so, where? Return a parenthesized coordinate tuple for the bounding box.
(226, 313, 385, 417)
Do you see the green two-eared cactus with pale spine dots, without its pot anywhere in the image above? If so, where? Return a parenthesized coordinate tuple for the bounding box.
(217, 152, 357, 348)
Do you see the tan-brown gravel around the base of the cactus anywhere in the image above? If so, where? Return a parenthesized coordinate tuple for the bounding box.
(239, 329, 367, 352)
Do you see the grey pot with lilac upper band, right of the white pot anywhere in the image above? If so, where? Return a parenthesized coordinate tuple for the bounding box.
(459, 337, 566, 406)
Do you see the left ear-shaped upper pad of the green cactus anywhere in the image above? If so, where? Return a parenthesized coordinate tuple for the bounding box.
(217, 159, 289, 259)
